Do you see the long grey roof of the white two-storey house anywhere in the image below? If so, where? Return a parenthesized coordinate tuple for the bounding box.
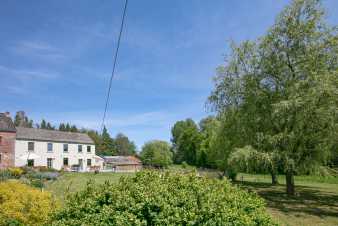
(16, 127, 94, 144)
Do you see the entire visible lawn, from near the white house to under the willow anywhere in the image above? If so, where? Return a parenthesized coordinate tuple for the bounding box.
(46, 170, 338, 226)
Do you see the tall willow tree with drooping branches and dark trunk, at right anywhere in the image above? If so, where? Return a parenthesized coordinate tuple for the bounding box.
(209, 0, 338, 195)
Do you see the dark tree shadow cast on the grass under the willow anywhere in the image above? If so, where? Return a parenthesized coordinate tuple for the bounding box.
(236, 181, 338, 218)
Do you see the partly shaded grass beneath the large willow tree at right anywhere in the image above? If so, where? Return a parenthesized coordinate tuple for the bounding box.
(237, 174, 338, 226)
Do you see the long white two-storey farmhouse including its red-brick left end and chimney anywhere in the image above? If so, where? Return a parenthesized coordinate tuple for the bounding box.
(0, 113, 102, 171)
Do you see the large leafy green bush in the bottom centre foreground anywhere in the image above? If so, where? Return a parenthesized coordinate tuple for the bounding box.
(52, 171, 274, 225)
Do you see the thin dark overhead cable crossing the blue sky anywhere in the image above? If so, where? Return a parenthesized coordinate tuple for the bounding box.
(101, 0, 128, 133)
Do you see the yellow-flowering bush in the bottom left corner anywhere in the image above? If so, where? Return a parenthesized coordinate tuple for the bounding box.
(0, 181, 56, 225)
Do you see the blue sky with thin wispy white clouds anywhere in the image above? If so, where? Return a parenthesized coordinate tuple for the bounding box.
(0, 0, 338, 148)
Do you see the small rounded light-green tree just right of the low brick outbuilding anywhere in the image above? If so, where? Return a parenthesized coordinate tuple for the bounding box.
(140, 140, 173, 167)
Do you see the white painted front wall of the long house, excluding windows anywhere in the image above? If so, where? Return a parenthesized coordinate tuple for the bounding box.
(15, 140, 96, 171)
